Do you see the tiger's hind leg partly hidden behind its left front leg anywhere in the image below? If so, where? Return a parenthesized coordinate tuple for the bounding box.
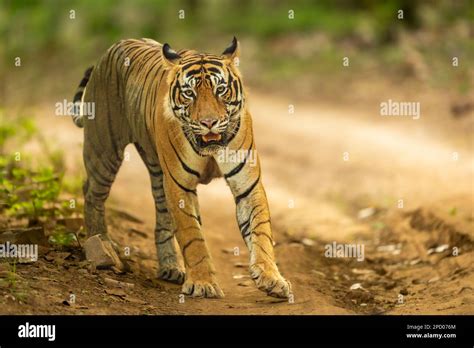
(135, 144, 185, 284)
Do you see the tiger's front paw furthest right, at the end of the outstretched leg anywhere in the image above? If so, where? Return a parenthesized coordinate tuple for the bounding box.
(250, 264, 292, 298)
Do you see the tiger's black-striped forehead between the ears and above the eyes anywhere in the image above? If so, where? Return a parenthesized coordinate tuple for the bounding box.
(180, 53, 229, 87)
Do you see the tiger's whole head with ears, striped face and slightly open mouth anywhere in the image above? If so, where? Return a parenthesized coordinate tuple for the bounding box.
(162, 37, 245, 156)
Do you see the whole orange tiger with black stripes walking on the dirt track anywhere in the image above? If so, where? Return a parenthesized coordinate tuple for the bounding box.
(73, 37, 292, 298)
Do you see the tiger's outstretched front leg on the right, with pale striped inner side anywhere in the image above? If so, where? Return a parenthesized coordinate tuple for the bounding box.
(217, 137, 291, 298)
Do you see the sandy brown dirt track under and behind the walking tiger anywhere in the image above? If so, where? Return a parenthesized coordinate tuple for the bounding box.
(0, 93, 474, 314)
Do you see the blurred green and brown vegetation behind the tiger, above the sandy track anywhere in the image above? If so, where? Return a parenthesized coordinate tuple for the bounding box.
(0, 0, 474, 102)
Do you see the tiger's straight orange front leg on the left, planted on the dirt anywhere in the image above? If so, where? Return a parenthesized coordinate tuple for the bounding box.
(164, 162, 224, 298)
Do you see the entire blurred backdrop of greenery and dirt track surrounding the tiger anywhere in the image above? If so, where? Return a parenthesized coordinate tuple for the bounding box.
(0, 0, 474, 314)
